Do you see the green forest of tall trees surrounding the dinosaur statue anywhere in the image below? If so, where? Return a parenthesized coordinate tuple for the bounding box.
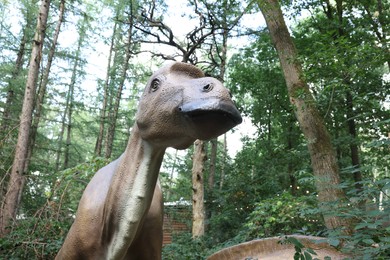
(0, 0, 390, 259)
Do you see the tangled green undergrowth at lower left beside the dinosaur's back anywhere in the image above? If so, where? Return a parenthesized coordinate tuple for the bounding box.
(0, 158, 108, 259)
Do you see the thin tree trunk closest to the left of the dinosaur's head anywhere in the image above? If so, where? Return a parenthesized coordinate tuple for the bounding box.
(105, 12, 133, 158)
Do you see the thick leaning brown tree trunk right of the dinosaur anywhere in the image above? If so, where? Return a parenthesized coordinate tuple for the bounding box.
(258, 0, 352, 233)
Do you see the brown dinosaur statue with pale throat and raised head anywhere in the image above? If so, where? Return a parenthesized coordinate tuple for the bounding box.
(56, 62, 242, 260)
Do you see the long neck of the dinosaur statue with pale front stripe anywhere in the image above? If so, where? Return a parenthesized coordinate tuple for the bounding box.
(103, 126, 165, 259)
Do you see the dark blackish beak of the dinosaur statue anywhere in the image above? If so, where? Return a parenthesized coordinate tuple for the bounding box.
(178, 98, 242, 140)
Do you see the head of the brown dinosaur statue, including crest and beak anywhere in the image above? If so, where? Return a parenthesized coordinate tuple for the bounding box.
(136, 62, 242, 149)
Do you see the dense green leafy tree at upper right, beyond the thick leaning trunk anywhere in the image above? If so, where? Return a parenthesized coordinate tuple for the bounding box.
(294, 1, 388, 197)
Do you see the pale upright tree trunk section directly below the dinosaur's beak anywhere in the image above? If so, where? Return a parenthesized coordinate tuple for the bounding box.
(192, 140, 206, 238)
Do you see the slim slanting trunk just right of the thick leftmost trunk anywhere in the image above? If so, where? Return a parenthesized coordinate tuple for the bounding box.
(27, 0, 65, 167)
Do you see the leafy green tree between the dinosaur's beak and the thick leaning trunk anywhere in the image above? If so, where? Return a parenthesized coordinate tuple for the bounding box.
(228, 30, 307, 197)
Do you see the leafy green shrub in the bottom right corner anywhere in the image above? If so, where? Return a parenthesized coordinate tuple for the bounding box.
(328, 177, 390, 259)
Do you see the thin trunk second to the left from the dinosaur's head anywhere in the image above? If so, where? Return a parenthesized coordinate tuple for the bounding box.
(95, 21, 118, 156)
